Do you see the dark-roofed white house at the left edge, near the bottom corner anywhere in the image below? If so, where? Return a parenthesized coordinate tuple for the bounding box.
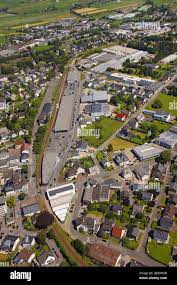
(0, 235, 20, 252)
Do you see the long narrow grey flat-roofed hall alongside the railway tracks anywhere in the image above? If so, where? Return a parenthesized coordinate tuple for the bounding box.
(54, 96, 74, 133)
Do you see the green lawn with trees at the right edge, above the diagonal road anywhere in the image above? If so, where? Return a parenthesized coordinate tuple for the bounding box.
(146, 93, 177, 116)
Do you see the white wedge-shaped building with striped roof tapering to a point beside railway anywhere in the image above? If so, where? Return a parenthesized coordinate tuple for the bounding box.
(47, 183, 75, 222)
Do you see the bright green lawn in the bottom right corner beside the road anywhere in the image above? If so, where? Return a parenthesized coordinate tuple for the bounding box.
(146, 240, 172, 265)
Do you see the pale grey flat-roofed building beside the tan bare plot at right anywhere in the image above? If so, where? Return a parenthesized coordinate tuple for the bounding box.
(132, 144, 163, 160)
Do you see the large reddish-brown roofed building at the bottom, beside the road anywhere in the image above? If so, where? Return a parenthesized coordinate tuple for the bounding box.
(88, 244, 122, 267)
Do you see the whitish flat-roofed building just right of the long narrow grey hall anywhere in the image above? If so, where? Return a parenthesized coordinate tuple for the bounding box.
(81, 89, 108, 103)
